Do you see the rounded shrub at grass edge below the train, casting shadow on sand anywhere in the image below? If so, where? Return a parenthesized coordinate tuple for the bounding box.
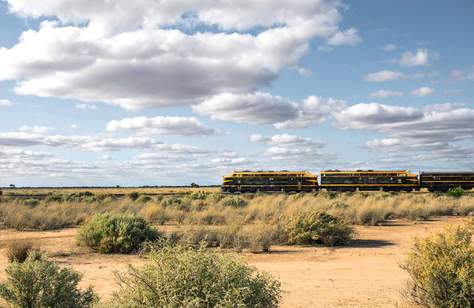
(285, 211, 354, 246)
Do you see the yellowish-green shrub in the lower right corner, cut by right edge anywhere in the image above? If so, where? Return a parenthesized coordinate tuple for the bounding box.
(401, 227, 474, 307)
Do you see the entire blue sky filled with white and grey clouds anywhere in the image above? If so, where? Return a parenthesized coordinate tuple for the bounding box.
(0, 0, 474, 186)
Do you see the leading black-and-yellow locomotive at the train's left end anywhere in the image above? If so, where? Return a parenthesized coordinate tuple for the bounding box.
(221, 171, 318, 192)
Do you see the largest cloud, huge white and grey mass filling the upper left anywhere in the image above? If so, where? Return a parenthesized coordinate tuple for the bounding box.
(0, 0, 360, 109)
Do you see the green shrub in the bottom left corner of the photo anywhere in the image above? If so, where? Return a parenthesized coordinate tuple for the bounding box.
(0, 257, 97, 308)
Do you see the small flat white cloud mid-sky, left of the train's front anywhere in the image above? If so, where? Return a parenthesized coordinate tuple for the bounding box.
(106, 116, 215, 135)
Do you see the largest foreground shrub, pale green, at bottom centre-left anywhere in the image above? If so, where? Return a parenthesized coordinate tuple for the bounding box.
(108, 246, 281, 308)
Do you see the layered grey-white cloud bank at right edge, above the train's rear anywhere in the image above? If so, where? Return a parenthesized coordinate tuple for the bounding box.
(336, 103, 474, 162)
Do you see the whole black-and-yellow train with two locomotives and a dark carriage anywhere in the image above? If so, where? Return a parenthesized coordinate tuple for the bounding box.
(221, 170, 474, 193)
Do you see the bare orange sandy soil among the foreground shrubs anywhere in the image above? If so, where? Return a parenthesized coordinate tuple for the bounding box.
(0, 217, 463, 307)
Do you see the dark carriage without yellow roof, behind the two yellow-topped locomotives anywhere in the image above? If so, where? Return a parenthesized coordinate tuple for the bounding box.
(420, 171, 474, 191)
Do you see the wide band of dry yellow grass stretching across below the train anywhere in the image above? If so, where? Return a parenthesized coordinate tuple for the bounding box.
(0, 192, 474, 230)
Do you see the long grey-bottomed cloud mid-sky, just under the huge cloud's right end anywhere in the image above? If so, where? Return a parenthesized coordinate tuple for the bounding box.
(193, 92, 344, 129)
